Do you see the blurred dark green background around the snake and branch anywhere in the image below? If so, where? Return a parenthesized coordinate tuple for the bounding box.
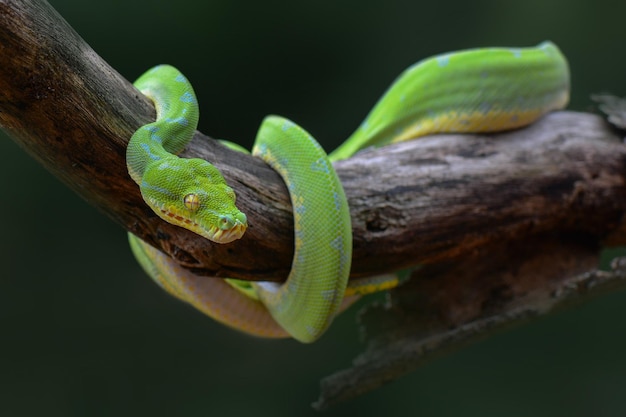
(0, 0, 626, 417)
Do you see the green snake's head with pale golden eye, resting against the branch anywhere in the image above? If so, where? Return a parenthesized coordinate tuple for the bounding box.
(139, 158, 248, 243)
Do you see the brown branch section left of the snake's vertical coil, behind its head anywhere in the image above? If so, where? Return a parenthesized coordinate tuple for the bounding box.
(0, 0, 292, 278)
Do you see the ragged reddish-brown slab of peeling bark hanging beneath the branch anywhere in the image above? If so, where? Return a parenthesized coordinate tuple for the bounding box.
(314, 234, 612, 409)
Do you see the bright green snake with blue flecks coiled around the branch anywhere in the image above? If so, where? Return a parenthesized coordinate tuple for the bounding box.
(127, 42, 569, 343)
